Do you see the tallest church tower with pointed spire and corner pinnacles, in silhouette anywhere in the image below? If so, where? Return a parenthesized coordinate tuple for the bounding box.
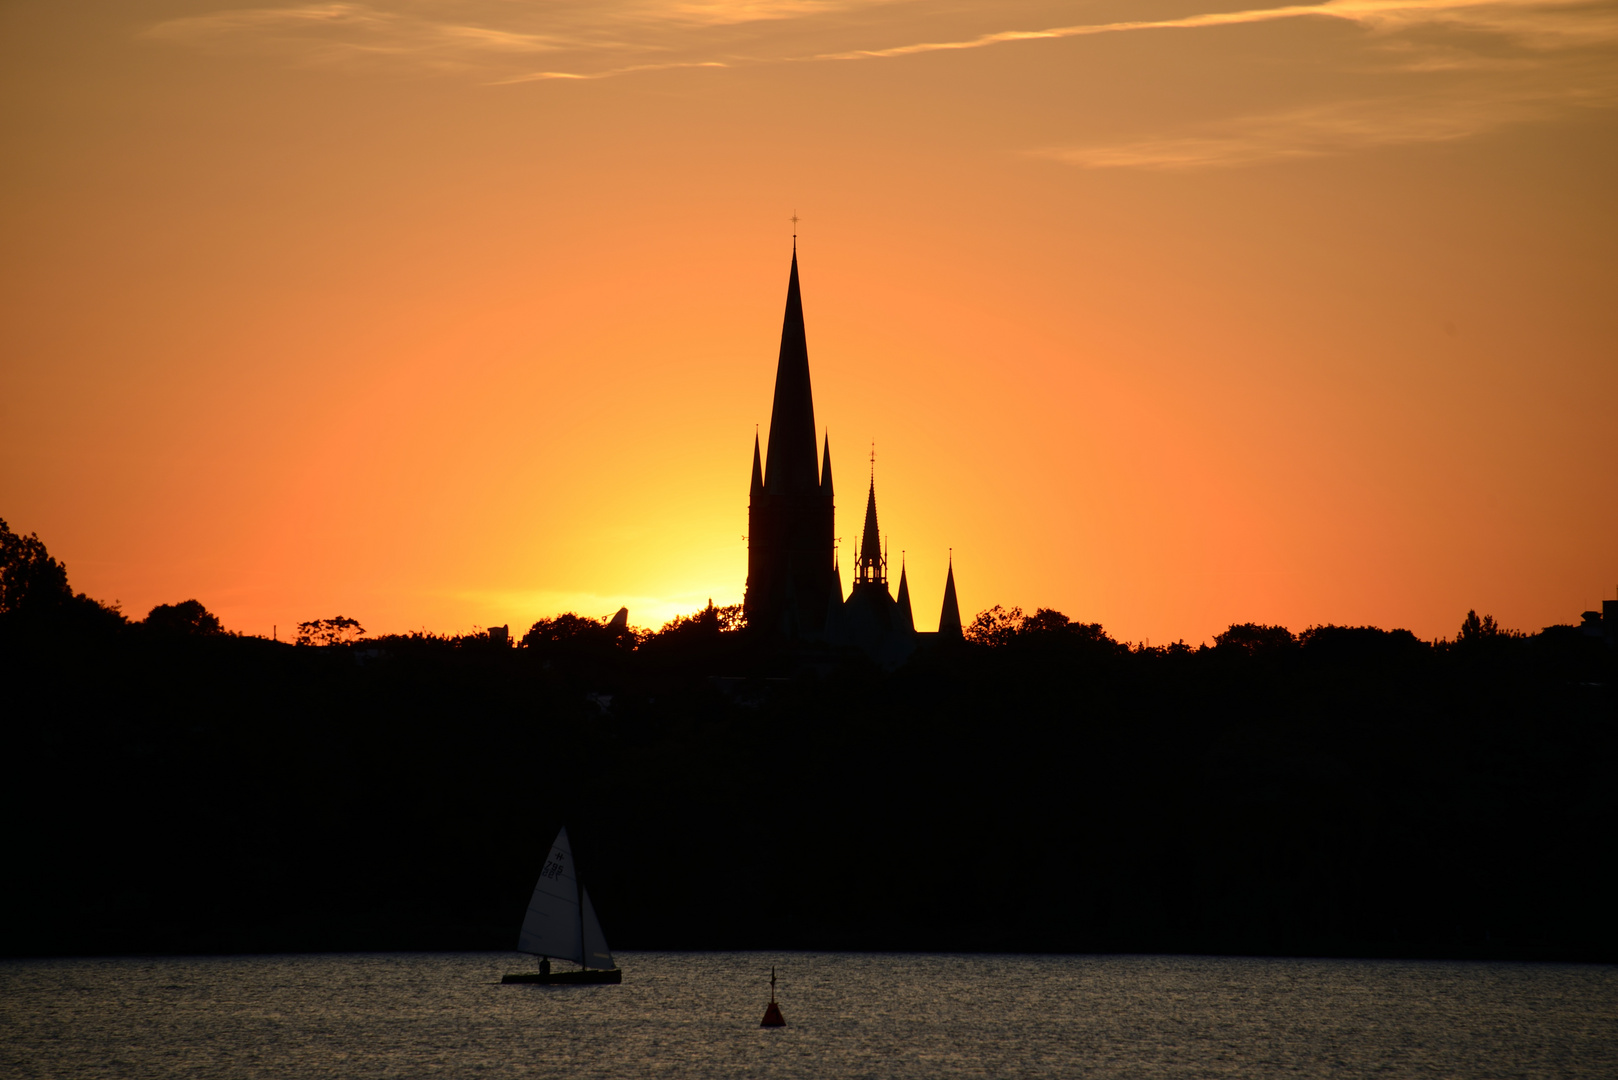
(743, 241, 841, 638)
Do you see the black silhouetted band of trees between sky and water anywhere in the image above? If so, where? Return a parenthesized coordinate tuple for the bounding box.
(0, 518, 1618, 960)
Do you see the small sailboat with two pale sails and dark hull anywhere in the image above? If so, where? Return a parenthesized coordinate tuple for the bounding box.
(500, 829, 623, 984)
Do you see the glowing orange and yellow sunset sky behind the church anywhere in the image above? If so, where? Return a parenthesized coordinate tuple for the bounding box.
(0, 0, 1618, 644)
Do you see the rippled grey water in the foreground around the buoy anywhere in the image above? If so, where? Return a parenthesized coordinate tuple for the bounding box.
(0, 952, 1618, 1080)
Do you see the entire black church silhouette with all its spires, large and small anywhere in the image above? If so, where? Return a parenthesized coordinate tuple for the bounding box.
(743, 238, 961, 665)
